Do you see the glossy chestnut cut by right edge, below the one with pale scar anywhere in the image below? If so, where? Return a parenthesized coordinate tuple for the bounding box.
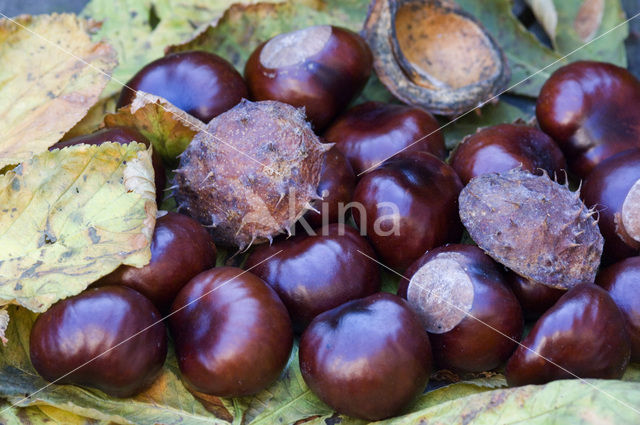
(596, 257, 640, 362)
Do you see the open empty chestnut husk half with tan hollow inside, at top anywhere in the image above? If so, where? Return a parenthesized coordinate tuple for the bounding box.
(363, 0, 510, 115)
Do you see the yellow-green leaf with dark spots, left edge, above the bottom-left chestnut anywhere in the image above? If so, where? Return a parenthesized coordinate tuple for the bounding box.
(0, 143, 157, 312)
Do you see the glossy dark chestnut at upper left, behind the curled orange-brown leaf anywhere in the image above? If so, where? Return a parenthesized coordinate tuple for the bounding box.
(117, 51, 248, 123)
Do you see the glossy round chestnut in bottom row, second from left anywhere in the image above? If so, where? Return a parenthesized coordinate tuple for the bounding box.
(170, 267, 293, 397)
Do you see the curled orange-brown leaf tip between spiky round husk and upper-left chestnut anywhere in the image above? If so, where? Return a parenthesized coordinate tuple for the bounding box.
(104, 91, 206, 164)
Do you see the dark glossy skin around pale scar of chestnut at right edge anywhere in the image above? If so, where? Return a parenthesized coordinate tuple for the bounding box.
(582, 149, 640, 263)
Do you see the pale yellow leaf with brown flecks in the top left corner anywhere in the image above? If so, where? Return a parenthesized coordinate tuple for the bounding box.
(0, 15, 117, 168)
